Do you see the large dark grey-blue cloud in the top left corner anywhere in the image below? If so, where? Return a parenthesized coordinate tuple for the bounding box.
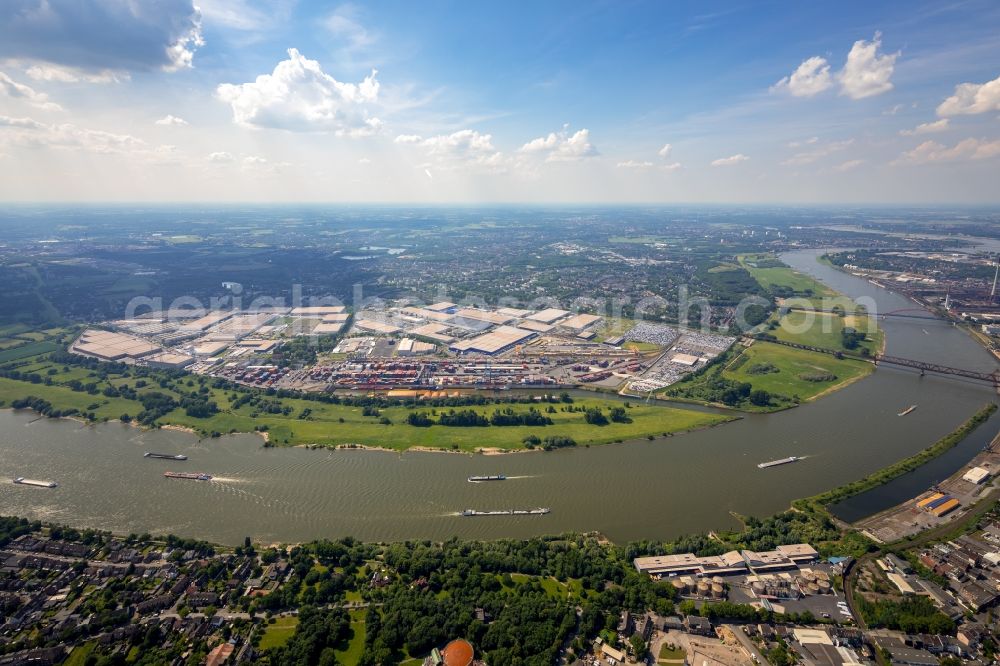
(0, 0, 203, 71)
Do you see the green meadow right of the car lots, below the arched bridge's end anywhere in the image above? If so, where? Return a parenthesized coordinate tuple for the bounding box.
(723, 342, 875, 401)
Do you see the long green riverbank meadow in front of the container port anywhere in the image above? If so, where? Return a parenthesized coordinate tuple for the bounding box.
(0, 342, 725, 452)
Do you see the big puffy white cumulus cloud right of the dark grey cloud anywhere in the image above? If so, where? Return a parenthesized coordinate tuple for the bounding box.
(216, 49, 382, 137)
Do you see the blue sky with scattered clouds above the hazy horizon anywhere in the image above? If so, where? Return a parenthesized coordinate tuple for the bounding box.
(0, 0, 1000, 204)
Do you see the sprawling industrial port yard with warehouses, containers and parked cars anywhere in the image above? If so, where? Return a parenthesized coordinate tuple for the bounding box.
(70, 301, 735, 395)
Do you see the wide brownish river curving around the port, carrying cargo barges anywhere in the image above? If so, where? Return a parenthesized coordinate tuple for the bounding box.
(0, 250, 998, 543)
